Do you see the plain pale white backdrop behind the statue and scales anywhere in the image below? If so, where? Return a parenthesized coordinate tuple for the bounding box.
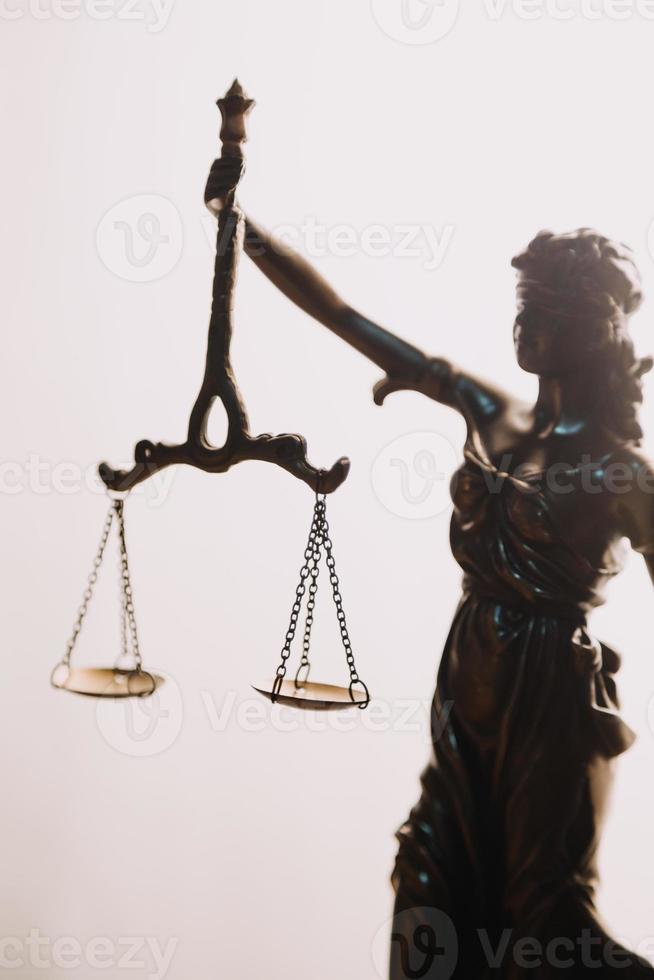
(0, 0, 654, 980)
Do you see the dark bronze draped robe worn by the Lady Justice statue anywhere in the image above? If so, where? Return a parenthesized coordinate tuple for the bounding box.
(391, 430, 654, 980)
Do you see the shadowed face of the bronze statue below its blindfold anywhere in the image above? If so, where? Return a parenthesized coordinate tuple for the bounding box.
(513, 304, 593, 377)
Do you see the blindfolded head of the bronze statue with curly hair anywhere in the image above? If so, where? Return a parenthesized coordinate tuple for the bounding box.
(512, 228, 652, 439)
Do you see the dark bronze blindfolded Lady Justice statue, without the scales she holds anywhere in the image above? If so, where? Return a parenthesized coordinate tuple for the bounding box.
(205, 105, 654, 980)
